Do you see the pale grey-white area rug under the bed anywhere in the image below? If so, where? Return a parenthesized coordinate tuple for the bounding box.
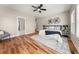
(31, 35, 71, 54)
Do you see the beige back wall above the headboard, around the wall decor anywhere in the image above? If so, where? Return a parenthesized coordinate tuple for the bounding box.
(37, 11, 70, 30)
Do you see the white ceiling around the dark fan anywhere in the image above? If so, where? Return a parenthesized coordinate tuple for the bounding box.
(0, 4, 72, 17)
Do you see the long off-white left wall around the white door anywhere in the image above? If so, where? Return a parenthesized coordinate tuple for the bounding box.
(0, 8, 35, 36)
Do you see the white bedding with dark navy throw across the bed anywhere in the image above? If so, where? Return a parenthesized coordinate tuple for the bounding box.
(39, 30, 62, 44)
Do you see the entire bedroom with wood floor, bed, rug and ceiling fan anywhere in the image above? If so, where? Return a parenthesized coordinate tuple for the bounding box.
(0, 4, 79, 54)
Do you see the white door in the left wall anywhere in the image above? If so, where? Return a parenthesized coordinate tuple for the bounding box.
(17, 17, 25, 35)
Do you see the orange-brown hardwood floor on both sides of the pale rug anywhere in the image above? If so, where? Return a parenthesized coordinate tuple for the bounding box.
(0, 34, 77, 54)
